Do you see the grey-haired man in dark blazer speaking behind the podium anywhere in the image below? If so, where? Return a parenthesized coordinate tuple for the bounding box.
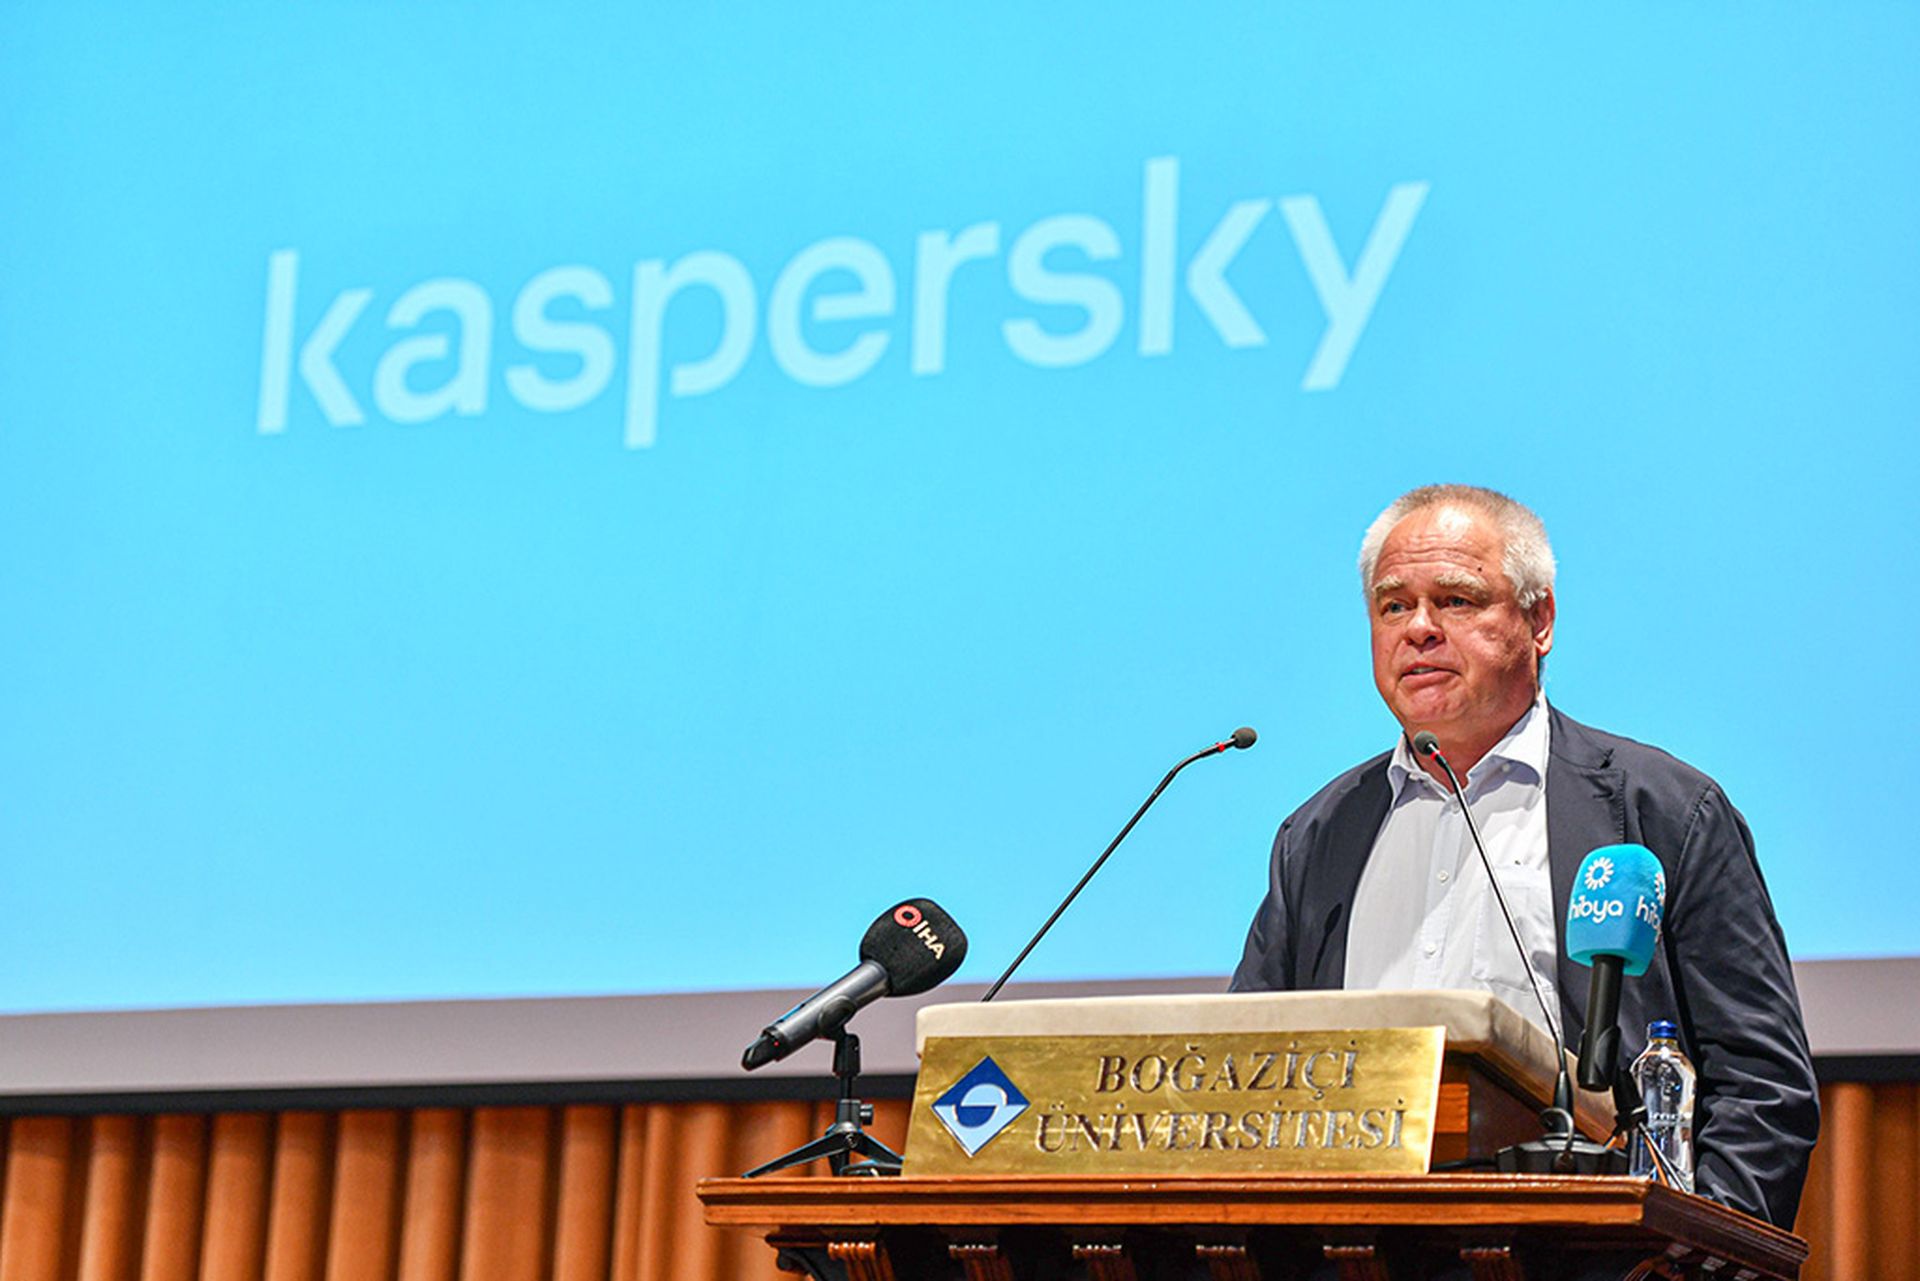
(1233, 486, 1820, 1227)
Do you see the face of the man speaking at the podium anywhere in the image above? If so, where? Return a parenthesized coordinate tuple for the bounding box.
(1371, 505, 1553, 752)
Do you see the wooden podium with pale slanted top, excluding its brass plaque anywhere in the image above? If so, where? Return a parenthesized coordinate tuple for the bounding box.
(699, 993, 1807, 1281)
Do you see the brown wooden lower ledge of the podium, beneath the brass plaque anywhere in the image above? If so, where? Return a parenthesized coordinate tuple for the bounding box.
(701, 1173, 1807, 1281)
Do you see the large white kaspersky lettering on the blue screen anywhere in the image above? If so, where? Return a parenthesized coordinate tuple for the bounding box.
(255, 156, 1428, 449)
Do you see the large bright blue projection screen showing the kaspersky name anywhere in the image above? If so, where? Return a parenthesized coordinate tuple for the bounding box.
(0, 0, 1920, 1012)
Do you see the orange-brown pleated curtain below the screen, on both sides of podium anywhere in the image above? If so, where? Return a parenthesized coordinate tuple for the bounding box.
(0, 1083, 1920, 1281)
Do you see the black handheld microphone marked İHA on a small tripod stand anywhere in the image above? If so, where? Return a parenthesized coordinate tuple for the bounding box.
(739, 899, 966, 1072)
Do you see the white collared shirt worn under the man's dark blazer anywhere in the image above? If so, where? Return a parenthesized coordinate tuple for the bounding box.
(1346, 693, 1559, 1044)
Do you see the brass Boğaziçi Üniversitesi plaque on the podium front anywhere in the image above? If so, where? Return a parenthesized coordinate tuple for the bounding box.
(906, 1027, 1446, 1175)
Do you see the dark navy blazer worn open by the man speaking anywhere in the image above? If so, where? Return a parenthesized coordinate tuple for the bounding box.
(1233, 709, 1820, 1227)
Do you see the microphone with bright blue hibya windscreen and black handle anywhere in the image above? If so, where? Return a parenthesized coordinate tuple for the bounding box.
(1567, 845, 1667, 1089)
